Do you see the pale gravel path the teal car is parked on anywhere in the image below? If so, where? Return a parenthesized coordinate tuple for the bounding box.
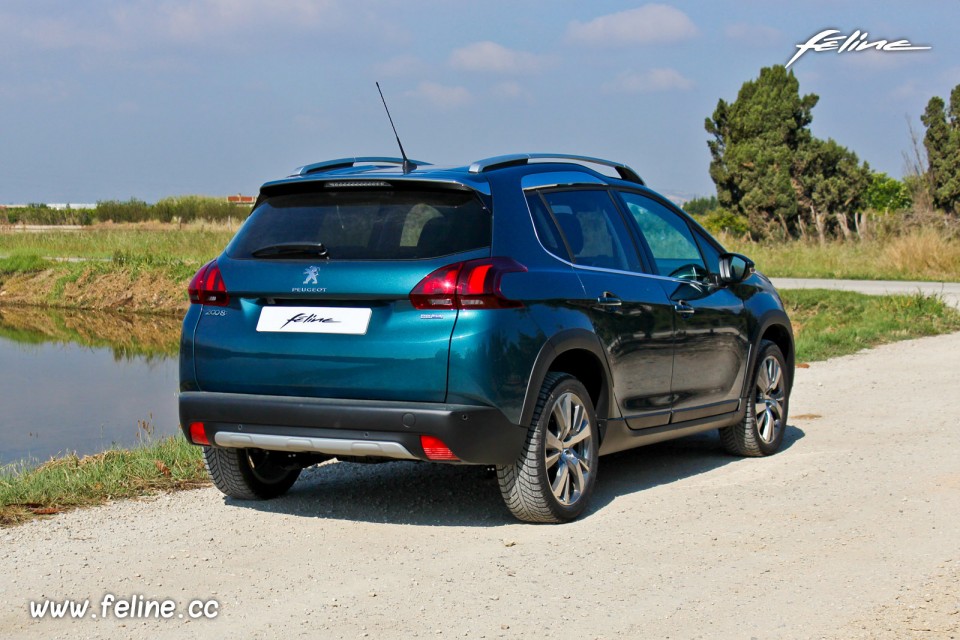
(0, 334, 960, 639)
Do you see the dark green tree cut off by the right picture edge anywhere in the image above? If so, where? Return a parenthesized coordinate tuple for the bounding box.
(920, 85, 960, 214)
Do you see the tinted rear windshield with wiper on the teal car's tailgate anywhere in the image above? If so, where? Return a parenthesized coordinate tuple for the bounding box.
(226, 190, 491, 260)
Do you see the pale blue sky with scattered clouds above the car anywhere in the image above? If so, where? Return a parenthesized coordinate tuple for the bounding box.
(0, 0, 960, 203)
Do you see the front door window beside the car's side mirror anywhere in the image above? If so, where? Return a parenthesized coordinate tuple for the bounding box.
(620, 193, 707, 279)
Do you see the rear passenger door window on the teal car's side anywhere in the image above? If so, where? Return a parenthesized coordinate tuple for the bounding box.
(541, 189, 640, 271)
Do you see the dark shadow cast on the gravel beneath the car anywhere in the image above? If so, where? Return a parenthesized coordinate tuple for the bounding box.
(224, 426, 804, 527)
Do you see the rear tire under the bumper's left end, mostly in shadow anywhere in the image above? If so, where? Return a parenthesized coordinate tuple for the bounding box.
(203, 447, 301, 500)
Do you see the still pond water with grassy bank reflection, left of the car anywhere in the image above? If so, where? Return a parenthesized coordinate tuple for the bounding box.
(0, 308, 180, 466)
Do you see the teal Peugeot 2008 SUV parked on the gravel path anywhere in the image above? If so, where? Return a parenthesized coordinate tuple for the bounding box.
(179, 154, 794, 522)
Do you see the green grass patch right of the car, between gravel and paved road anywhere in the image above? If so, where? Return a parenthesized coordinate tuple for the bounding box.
(780, 289, 960, 362)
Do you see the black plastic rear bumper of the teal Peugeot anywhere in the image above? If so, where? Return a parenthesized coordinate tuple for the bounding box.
(180, 391, 527, 464)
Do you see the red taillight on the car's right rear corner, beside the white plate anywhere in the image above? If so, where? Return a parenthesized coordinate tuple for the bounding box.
(410, 258, 527, 309)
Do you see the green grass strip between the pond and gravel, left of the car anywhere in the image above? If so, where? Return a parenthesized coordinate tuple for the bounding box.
(0, 435, 210, 526)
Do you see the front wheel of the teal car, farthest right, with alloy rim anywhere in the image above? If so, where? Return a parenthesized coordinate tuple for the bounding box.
(720, 340, 790, 457)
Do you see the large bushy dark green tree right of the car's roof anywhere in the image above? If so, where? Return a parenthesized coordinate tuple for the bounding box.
(705, 66, 870, 242)
